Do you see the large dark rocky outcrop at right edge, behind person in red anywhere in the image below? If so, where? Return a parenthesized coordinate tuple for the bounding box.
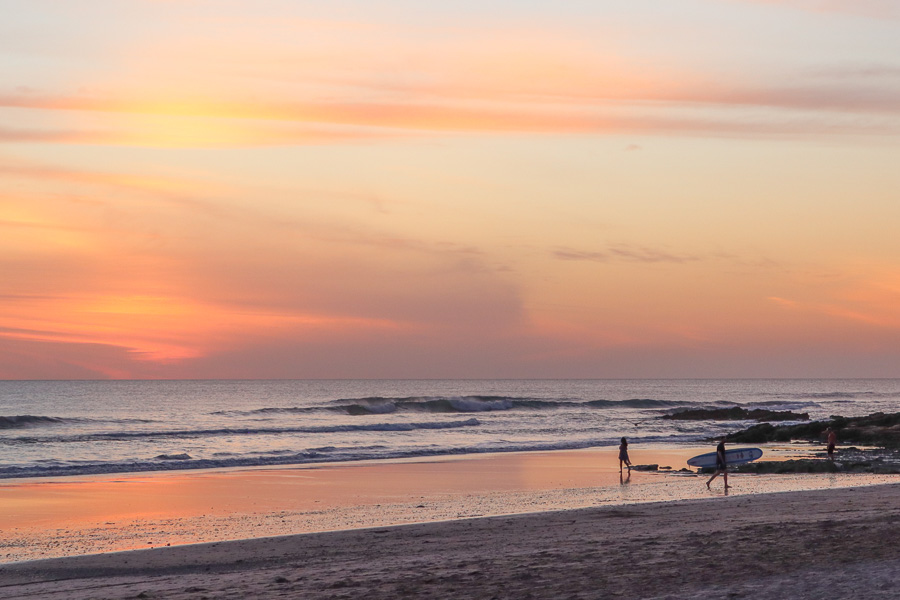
(725, 412, 900, 448)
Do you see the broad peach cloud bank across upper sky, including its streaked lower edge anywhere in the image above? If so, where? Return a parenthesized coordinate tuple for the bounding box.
(0, 10, 900, 147)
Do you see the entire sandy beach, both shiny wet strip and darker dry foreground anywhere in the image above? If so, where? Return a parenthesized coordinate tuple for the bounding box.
(0, 447, 900, 599)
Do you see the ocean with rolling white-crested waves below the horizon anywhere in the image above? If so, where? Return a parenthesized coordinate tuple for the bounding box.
(0, 379, 900, 479)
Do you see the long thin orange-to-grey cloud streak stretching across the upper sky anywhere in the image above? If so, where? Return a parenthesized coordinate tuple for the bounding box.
(0, 87, 900, 149)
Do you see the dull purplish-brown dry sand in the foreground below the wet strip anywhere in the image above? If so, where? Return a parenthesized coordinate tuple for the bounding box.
(0, 485, 900, 600)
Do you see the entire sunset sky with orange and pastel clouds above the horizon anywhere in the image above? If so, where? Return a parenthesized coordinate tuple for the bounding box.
(0, 0, 900, 379)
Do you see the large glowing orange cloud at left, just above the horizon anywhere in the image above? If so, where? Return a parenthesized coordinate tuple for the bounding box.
(0, 158, 521, 377)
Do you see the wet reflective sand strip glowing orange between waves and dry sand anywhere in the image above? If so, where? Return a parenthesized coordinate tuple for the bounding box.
(0, 445, 900, 564)
